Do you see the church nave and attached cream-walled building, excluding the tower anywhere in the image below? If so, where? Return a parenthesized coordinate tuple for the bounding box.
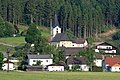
(51, 33, 88, 48)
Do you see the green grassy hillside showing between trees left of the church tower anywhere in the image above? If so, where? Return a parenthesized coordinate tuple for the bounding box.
(0, 25, 50, 52)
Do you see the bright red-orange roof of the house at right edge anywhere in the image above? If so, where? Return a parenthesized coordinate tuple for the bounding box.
(105, 57, 120, 66)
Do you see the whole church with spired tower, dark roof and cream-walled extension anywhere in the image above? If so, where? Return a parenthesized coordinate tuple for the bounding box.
(51, 15, 88, 48)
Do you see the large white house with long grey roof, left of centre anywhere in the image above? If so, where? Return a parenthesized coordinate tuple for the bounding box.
(26, 54, 53, 66)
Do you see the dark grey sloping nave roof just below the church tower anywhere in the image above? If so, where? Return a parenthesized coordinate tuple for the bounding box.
(52, 33, 71, 42)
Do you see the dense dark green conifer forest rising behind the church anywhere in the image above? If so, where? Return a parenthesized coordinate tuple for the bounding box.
(0, 0, 120, 38)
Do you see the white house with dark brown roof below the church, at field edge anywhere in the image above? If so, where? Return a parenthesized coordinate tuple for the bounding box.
(67, 56, 89, 71)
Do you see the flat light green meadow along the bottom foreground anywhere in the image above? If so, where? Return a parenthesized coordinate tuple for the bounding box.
(0, 71, 120, 80)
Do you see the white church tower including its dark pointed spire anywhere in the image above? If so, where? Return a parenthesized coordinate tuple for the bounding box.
(51, 14, 61, 38)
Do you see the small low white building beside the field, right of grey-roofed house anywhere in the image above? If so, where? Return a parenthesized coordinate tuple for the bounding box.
(47, 64, 64, 71)
